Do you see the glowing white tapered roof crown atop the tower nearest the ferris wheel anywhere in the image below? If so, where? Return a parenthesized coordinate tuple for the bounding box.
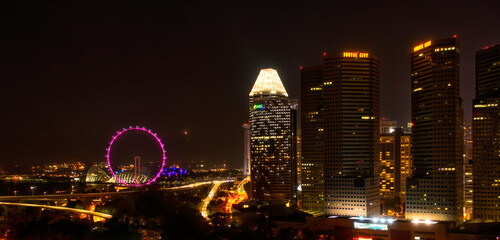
(250, 68, 288, 97)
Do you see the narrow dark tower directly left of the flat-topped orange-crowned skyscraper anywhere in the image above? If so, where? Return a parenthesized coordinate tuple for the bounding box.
(300, 66, 325, 215)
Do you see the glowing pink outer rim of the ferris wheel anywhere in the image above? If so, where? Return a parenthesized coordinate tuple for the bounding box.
(106, 126, 167, 187)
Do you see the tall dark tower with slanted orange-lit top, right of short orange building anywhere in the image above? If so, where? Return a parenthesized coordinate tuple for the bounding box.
(406, 37, 464, 221)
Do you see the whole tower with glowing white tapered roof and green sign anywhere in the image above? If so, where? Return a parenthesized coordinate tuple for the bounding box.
(249, 68, 296, 202)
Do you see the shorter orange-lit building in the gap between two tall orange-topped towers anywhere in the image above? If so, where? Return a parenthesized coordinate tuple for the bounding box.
(380, 128, 411, 215)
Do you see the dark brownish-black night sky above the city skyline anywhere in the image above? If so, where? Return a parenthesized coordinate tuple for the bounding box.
(0, 1, 500, 170)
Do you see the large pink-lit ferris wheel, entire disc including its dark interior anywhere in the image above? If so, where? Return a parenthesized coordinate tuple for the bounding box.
(106, 126, 167, 187)
